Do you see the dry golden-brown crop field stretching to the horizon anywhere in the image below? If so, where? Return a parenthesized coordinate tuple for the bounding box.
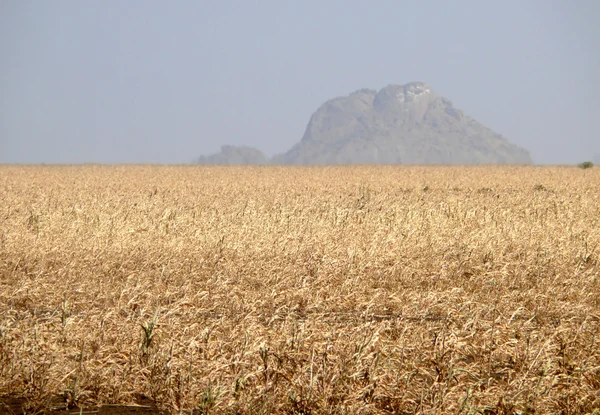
(0, 166, 600, 415)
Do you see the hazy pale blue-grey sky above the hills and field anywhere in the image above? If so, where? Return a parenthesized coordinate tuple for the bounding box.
(0, 0, 600, 164)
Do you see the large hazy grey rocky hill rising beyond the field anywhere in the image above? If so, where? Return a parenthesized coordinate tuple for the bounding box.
(195, 82, 531, 164)
